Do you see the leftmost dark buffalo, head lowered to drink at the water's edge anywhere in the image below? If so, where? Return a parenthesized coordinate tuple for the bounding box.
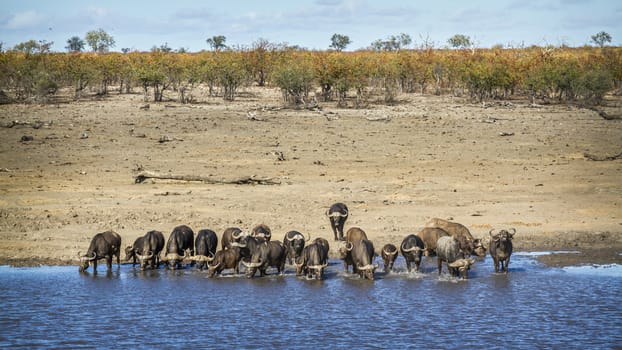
(78, 231, 121, 272)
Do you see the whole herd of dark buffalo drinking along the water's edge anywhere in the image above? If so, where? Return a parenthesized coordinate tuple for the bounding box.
(78, 203, 516, 280)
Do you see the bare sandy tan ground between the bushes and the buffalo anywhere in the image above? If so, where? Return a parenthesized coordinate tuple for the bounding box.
(0, 88, 622, 265)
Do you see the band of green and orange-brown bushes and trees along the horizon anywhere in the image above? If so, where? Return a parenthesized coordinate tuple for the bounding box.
(0, 39, 622, 107)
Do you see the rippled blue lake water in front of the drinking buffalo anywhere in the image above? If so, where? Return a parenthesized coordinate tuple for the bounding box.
(0, 252, 622, 349)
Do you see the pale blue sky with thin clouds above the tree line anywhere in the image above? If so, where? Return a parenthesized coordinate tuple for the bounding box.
(0, 0, 622, 52)
